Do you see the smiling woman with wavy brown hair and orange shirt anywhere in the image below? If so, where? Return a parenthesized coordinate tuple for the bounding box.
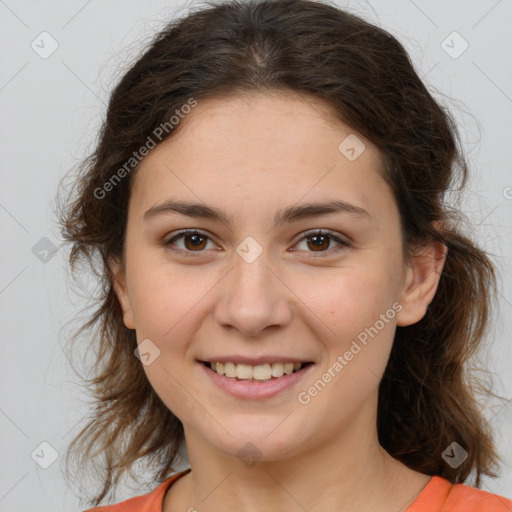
(57, 0, 512, 512)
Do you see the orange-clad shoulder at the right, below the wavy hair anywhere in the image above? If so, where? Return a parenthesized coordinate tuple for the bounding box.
(406, 476, 512, 512)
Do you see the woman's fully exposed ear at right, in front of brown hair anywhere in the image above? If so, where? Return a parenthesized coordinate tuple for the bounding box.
(397, 240, 448, 326)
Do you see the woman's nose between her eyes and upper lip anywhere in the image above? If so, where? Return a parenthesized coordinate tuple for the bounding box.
(215, 253, 293, 337)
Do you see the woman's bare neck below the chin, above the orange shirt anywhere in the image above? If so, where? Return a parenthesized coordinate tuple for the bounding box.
(164, 398, 429, 512)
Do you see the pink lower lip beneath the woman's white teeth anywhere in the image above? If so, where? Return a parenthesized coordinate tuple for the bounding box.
(198, 363, 314, 399)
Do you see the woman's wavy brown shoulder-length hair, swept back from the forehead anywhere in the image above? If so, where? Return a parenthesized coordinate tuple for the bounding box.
(59, 0, 499, 505)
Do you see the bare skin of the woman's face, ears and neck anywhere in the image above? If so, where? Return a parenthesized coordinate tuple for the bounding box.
(112, 92, 445, 512)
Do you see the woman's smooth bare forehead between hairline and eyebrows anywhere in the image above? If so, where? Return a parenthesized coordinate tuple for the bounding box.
(132, 93, 389, 222)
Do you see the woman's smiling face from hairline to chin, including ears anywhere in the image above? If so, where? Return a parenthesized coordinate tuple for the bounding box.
(114, 94, 439, 460)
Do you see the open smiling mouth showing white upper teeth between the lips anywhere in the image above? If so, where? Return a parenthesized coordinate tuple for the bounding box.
(199, 361, 313, 382)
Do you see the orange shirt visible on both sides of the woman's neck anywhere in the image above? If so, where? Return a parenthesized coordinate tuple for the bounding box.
(84, 468, 512, 512)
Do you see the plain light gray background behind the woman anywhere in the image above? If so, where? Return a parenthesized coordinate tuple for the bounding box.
(0, 0, 512, 512)
